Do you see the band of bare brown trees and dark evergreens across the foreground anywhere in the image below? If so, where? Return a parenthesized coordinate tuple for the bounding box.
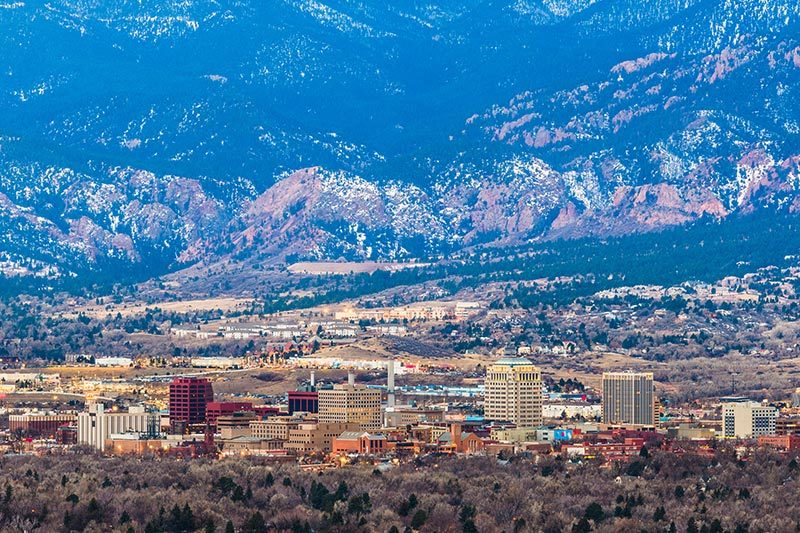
(0, 449, 800, 533)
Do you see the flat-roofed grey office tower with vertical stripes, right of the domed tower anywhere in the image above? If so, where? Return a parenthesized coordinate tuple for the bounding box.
(603, 372, 655, 426)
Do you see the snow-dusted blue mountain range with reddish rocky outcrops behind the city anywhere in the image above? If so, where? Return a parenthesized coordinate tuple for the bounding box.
(0, 0, 800, 284)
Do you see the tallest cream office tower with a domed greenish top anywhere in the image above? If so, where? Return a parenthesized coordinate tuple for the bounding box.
(484, 357, 542, 427)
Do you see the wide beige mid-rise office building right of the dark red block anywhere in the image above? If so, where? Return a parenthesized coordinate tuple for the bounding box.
(317, 379, 382, 431)
